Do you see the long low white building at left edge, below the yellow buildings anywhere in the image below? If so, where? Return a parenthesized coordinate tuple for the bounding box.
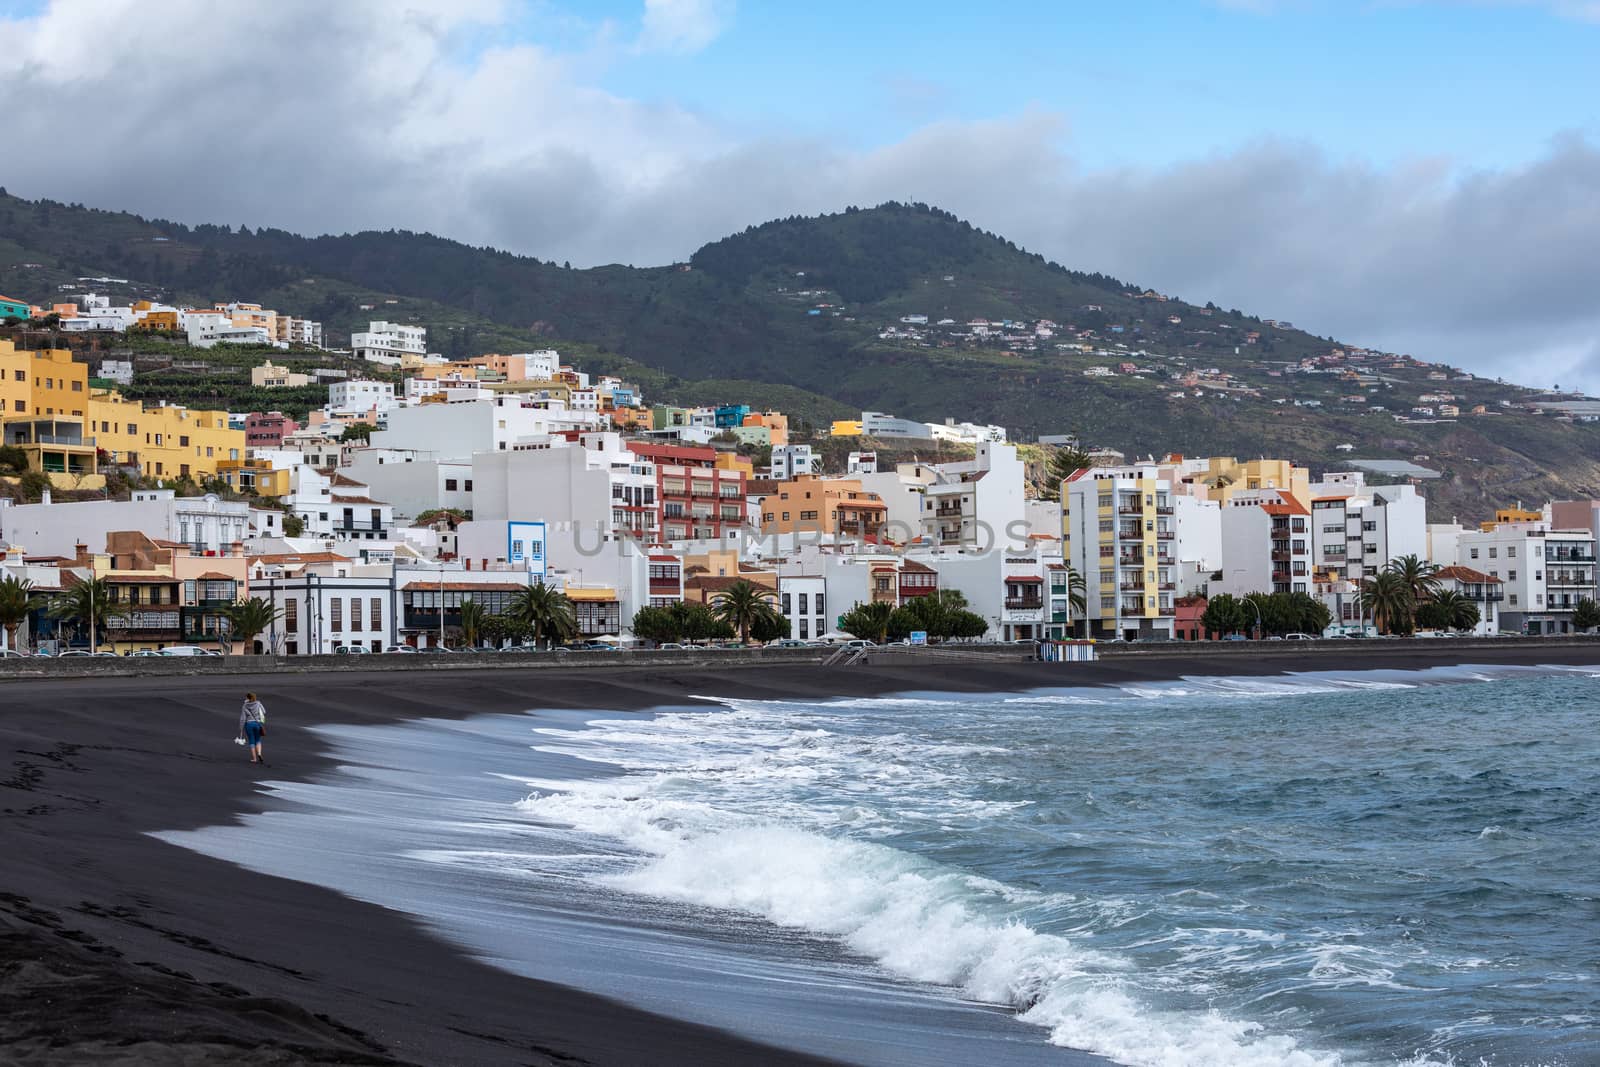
(0, 490, 250, 558)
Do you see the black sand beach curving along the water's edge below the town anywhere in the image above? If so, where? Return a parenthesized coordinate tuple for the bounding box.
(0, 641, 1600, 1064)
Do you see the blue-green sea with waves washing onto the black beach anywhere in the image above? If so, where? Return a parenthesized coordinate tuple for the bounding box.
(158, 665, 1600, 1067)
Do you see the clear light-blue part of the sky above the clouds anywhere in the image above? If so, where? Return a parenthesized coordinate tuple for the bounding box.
(576, 0, 1600, 166)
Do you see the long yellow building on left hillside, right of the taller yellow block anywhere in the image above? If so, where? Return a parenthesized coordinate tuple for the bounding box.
(86, 392, 245, 482)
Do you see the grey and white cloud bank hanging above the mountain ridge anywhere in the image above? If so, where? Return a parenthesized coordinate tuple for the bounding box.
(0, 0, 1600, 389)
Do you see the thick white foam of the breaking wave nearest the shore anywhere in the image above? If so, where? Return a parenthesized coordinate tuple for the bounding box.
(520, 777, 1363, 1067)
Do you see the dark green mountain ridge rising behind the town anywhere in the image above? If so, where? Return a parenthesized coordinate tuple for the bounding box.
(0, 194, 1600, 518)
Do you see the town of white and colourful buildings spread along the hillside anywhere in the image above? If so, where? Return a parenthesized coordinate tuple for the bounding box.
(0, 295, 1600, 656)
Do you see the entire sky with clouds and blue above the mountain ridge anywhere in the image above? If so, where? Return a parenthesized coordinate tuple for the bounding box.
(0, 0, 1600, 392)
